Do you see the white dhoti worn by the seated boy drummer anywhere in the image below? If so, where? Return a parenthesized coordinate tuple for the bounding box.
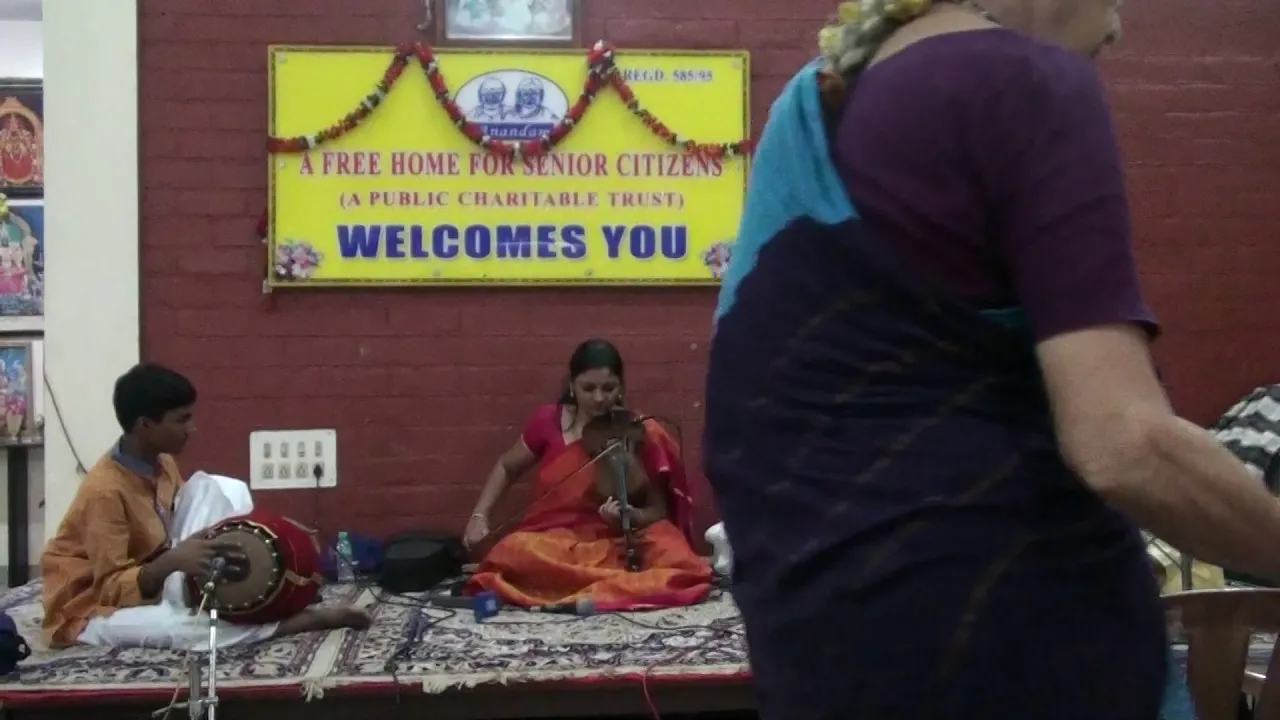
(78, 473, 279, 651)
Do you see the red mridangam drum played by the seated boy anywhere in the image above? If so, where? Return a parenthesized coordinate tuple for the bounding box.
(187, 510, 324, 624)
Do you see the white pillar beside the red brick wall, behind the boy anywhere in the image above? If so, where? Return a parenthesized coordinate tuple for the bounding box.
(32, 0, 140, 559)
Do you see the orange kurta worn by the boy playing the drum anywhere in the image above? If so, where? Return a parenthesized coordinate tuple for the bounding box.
(40, 455, 182, 647)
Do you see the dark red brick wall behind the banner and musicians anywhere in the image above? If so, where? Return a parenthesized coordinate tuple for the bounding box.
(140, 0, 1280, 532)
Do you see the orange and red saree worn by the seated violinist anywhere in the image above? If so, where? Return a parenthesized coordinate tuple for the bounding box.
(470, 421, 712, 604)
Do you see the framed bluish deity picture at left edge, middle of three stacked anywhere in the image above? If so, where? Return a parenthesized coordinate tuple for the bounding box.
(0, 200, 45, 333)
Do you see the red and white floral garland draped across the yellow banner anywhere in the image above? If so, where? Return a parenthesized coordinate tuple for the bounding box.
(266, 42, 755, 159)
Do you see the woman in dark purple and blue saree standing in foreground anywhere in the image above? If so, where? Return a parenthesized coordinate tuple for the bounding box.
(704, 0, 1280, 720)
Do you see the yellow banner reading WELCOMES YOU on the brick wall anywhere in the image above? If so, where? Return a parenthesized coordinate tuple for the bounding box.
(268, 46, 750, 287)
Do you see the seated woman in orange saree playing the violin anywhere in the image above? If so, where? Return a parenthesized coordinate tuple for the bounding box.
(463, 340, 712, 611)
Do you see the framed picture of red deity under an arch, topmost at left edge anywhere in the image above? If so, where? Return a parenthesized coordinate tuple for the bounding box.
(0, 79, 45, 197)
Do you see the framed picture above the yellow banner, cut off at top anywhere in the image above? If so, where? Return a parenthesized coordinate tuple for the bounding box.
(433, 0, 582, 46)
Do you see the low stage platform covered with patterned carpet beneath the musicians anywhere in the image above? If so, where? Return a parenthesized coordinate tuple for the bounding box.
(0, 582, 754, 720)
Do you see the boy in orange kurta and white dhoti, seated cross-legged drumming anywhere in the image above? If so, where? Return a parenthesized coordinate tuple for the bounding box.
(41, 364, 369, 650)
